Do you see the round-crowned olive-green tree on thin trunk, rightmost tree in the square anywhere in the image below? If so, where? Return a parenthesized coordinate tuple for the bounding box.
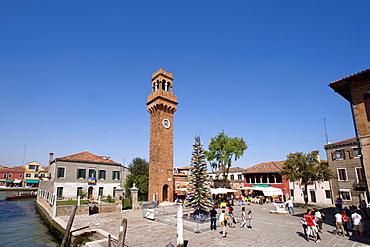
(280, 152, 336, 206)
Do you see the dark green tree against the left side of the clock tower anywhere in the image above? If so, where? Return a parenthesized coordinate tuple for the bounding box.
(125, 157, 149, 200)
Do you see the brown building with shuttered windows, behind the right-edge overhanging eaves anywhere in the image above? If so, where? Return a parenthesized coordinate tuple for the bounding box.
(324, 138, 366, 205)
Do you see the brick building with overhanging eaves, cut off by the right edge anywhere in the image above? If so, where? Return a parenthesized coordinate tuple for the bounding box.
(329, 69, 370, 202)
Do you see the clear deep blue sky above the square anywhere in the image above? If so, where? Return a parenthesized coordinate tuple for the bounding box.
(0, 0, 370, 168)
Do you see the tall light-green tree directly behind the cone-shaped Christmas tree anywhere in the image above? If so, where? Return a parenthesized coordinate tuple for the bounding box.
(204, 131, 248, 186)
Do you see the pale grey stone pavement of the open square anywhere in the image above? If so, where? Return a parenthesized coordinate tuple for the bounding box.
(57, 204, 370, 247)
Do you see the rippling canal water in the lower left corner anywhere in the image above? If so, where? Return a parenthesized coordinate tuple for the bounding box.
(0, 191, 60, 247)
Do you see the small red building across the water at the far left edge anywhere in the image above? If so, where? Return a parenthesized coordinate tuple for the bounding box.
(0, 166, 25, 187)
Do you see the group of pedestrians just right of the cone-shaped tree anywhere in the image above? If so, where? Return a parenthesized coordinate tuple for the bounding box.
(210, 205, 253, 238)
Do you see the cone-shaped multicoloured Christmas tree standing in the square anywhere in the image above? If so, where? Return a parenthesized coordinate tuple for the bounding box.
(185, 136, 213, 213)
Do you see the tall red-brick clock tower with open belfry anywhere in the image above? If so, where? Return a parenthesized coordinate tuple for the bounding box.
(146, 68, 177, 203)
